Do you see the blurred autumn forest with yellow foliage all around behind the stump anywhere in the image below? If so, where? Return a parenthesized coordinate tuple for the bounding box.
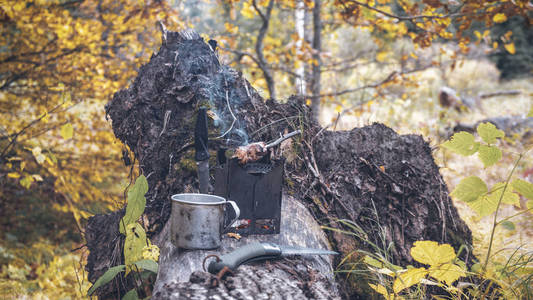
(0, 0, 533, 299)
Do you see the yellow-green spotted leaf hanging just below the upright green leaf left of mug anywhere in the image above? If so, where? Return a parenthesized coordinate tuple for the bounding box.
(124, 222, 146, 275)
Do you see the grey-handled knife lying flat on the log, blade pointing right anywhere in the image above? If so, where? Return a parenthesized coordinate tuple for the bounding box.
(207, 242, 339, 274)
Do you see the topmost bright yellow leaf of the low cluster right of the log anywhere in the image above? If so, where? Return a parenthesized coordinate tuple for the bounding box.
(411, 241, 456, 266)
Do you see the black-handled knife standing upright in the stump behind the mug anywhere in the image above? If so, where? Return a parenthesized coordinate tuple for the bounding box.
(194, 107, 209, 194)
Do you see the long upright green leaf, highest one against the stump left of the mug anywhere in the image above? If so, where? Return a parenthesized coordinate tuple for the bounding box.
(119, 175, 148, 234)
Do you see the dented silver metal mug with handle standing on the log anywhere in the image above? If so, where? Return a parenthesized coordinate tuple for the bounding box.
(170, 194, 240, 249)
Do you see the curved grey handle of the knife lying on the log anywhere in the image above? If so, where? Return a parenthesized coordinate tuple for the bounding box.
(207, 242, 281, 274)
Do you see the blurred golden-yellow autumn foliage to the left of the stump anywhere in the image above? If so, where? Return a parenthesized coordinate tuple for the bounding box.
(0, 0, 181, 298)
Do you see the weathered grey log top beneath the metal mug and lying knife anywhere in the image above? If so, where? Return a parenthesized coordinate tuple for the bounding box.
(152, 195, 339, 299)
